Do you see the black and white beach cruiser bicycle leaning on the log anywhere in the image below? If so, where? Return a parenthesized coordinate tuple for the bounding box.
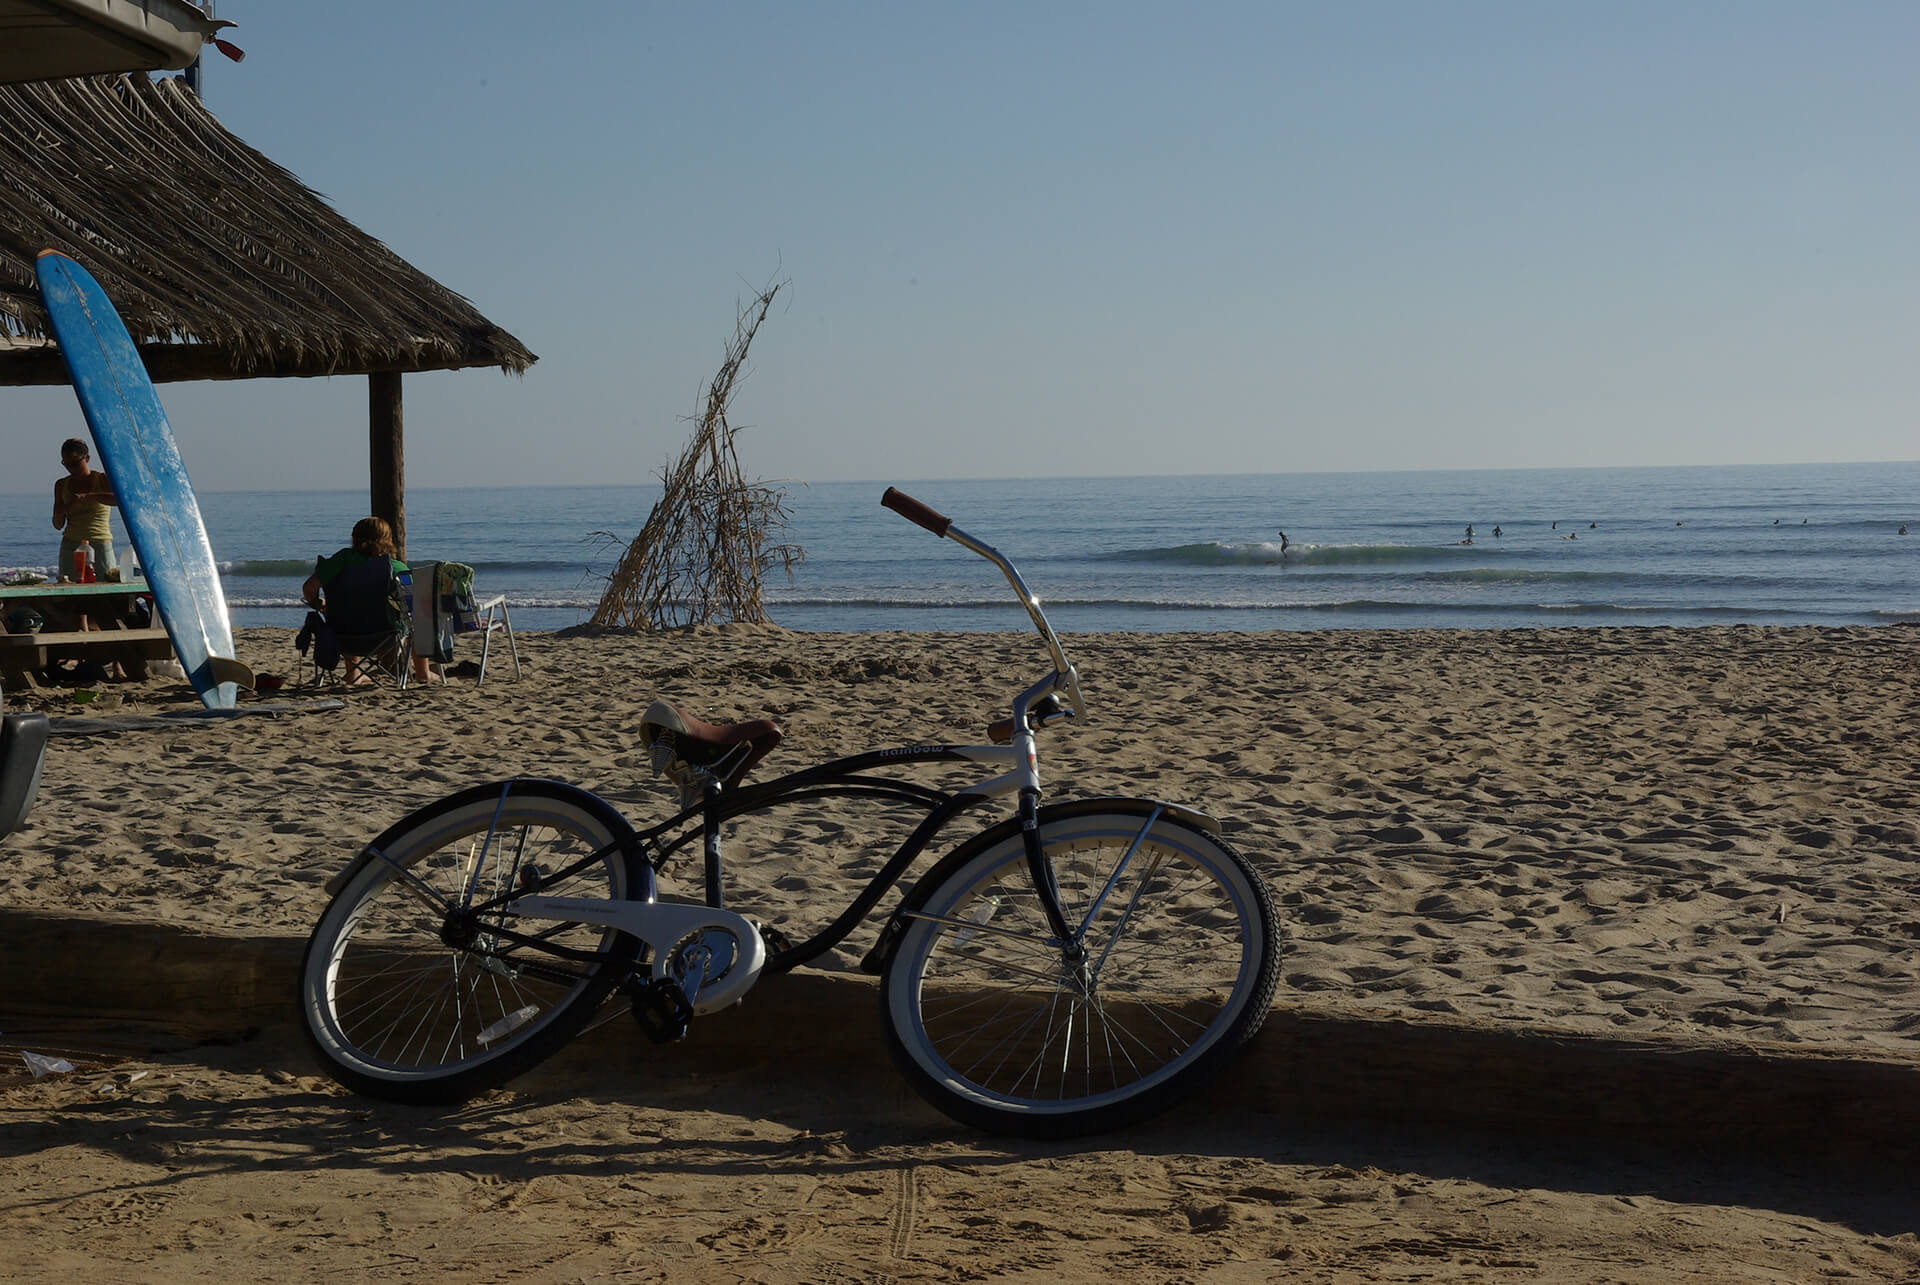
(300, 488, 1281, 1137)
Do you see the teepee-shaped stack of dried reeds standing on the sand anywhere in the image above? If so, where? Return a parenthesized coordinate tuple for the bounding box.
(593, 282, 804, 632)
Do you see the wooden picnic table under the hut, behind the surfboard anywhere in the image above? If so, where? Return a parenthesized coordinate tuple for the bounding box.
(0, 580, 173, 688)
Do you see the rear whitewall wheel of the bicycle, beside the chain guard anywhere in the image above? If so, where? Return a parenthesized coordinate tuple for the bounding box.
(300, 780, 653, 1103)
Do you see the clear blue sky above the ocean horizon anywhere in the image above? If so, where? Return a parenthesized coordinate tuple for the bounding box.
(4, 0, 1920, 490)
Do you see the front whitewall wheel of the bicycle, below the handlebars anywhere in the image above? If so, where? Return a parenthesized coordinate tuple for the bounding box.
(881, 799, 1281, 1137)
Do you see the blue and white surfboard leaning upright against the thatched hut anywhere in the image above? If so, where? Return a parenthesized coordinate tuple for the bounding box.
(35, 250, 253, 709)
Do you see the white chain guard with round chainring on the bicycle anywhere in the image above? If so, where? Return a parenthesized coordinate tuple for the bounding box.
(507, 897, 766, 1014)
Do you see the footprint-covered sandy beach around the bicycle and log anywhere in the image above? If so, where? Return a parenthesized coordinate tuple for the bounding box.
(0, 626, 1920, 1281)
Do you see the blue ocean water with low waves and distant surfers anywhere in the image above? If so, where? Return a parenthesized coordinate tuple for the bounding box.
(0, 463, 1920, 632)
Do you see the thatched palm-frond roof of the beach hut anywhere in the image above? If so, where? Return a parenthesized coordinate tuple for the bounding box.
(0, 75, 536, 384)
